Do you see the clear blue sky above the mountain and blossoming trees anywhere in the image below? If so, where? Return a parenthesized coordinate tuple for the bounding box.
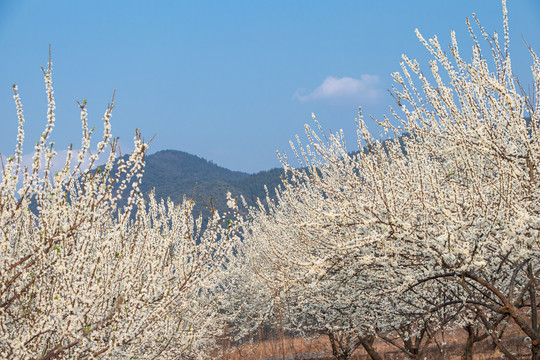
(0, 0, 540, 172)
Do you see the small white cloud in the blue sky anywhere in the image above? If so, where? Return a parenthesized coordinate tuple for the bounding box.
(294, 74, 382, 105)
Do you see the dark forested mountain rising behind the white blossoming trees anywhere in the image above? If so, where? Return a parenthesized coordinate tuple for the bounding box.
(140, 150, 283, 214)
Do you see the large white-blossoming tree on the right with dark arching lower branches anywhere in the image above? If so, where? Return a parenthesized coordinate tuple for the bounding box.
(243, 1, 540, 359)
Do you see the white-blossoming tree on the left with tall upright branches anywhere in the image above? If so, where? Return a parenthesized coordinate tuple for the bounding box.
(0, 54, 238, 360)
